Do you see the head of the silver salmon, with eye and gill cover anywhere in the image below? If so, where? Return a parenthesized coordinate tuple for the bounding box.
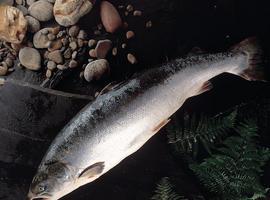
(27, 162, 77, 200)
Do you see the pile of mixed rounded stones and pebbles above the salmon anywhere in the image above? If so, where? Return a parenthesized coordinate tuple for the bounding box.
(0, 0, 152, 82)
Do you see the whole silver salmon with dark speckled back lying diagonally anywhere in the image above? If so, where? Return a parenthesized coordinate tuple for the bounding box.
(28, 38, 264, 200)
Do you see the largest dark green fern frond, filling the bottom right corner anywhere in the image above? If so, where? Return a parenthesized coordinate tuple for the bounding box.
(190, 121, 270, 200)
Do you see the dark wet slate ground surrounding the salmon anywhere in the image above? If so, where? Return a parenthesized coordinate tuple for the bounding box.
(0, 0, 270, 200)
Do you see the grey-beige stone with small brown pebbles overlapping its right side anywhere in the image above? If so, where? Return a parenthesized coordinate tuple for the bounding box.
(33, 28, 52, 49)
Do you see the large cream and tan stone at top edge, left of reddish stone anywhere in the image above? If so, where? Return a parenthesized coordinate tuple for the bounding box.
(53, 0, 94, 27)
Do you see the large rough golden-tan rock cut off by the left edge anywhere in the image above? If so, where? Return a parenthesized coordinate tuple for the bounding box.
(0, 5, 27, 44)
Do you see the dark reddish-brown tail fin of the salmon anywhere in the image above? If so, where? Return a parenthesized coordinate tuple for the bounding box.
(231, 37, 265, 81)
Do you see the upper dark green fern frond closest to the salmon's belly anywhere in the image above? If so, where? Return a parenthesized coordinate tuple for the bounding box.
(168, 110, 237, 157)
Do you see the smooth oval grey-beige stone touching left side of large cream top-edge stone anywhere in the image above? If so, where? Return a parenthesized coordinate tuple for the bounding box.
(28, 1, 53, 22)
